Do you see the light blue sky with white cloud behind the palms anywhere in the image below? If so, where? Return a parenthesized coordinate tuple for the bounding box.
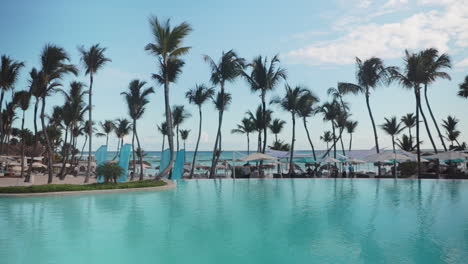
(0, 0, 468, 150)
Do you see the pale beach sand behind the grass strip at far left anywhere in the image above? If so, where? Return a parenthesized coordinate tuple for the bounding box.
(0, 174, 96, 187)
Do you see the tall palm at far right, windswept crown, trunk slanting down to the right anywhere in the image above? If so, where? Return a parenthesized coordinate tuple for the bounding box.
(421, 48, 452, 151)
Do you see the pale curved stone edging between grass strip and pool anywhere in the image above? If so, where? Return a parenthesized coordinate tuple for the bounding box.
(0, 179, 177, 198)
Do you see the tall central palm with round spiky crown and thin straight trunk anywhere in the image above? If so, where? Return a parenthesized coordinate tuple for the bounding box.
(242, 55, 286, 153)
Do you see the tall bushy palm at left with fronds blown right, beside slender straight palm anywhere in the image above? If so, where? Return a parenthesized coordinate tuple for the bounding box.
(38, 44, 78, 183)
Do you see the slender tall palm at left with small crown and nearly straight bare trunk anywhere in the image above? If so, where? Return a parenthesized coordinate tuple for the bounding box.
(78, 44, 111, 182)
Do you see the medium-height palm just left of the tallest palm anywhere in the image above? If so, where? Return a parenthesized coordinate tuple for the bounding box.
(120, 79, 154, 181)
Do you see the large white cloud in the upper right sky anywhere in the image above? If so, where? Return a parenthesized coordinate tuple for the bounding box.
(285, 0, 468, 64)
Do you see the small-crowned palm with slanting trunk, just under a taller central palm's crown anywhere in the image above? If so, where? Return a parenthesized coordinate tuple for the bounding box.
(209, 92, 232, 178)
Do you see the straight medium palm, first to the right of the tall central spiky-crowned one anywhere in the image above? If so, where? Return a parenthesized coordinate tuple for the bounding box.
(270, 84, 310, 175)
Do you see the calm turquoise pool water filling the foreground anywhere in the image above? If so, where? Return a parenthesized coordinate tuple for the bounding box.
(0, 179, 468, 264)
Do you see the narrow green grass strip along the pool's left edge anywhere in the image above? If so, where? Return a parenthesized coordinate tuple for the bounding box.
(0, 180, 166, 193)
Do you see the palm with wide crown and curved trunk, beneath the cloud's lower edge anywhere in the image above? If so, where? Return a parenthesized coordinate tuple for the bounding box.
(339, 57, 395, 153)
